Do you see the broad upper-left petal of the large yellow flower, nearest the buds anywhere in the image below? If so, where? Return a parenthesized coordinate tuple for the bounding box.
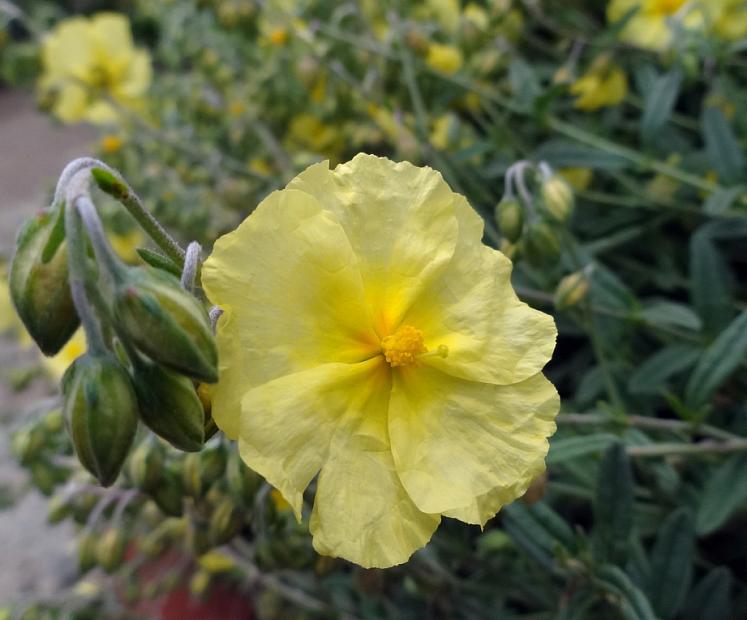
(202, 190, 379, 437)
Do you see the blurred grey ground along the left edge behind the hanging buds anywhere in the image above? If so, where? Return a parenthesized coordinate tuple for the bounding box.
(0, 89, 94, 606)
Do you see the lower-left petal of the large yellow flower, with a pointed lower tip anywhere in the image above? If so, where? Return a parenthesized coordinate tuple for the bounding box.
(239, 358, 389, 517)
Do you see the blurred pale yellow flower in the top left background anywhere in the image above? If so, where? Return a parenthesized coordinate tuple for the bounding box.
(39, 13, 151, 124)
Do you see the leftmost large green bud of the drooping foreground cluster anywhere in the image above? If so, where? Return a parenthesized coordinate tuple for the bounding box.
(9, 207, 80, 355)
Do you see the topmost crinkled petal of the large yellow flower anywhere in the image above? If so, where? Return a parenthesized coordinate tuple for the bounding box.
(288, 154, 459, 335)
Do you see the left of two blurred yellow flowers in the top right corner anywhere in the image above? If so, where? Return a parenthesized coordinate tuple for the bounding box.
(607, 0, 712, 51)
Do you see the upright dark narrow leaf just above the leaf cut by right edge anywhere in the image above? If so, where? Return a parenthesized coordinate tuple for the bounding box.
(690, 230, 733, 334)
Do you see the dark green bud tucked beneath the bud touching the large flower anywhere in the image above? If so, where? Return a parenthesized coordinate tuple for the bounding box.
(135, 363, 205, 452)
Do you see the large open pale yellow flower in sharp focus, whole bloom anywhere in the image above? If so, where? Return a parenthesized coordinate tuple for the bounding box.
(202, 155, 559, 567)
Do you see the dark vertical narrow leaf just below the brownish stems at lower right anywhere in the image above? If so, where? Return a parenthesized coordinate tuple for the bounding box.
(593, 443, 633, 563)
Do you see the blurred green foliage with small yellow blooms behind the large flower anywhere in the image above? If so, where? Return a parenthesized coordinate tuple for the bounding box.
(0, 0, 747, 620)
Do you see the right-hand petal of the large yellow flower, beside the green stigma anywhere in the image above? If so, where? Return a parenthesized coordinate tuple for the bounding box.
(403, 197, 557, 385)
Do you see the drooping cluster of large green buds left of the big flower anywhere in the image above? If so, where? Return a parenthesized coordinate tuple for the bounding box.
(10, 165, 218, 490)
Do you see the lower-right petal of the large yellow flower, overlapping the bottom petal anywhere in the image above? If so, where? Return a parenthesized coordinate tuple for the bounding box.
(389, 367, 560, 523)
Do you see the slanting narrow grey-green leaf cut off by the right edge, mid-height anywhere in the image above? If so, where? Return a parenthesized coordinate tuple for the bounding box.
(685, 310, 747, 409)
